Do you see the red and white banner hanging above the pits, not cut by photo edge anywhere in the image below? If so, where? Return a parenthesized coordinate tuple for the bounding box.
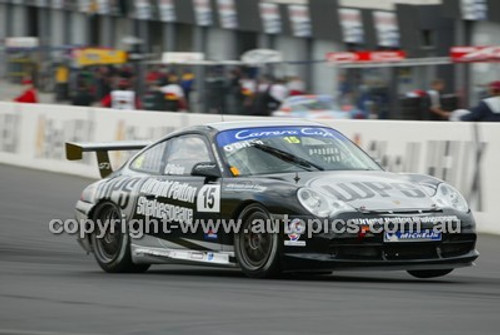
(326, 50, 406, 63)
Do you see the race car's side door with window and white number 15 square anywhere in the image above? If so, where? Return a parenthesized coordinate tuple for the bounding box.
(160, 134, 221, 250)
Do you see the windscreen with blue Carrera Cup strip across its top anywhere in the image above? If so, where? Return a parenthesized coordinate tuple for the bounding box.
(217, 127, 380, 176)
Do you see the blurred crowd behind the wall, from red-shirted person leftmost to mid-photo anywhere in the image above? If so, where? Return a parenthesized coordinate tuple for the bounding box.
(15, 65, 305, 115)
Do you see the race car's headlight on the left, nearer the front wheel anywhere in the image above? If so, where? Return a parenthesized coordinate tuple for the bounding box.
(297, 188, 352, 218)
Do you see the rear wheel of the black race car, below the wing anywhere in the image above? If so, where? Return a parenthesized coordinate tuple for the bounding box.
(91, 203, 149, 273)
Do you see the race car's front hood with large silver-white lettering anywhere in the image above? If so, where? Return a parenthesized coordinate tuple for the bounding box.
(260, 171, 441, 211)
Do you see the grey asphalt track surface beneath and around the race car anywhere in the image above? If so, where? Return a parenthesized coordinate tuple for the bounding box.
(0, 165, 500, 335)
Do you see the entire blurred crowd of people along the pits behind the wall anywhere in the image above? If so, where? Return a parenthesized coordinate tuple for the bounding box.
(10, 65, 500, 121)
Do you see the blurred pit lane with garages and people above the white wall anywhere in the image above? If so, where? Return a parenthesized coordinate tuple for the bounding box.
(0, 0, 500, 120)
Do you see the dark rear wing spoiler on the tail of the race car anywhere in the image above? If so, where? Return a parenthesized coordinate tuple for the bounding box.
(66, 141, 151, 178)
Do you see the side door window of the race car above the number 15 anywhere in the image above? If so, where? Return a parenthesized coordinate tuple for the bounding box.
(164, 135, 213, 176)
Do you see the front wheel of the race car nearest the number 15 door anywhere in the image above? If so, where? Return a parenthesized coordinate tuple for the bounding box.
(234, 204, 281, 278)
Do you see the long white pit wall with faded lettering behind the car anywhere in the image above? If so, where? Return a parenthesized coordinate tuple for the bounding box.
(0, 102, 500, 234)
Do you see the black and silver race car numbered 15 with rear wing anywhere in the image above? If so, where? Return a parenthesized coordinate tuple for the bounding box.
(66, 120, 478, 278)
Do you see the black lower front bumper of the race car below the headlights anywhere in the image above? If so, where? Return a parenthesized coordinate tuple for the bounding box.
(283, 212, 479, 272)
